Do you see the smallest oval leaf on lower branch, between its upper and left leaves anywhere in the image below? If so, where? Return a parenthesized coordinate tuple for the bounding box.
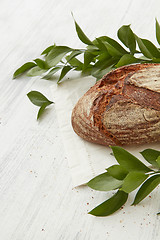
(107, 165, 128, 180)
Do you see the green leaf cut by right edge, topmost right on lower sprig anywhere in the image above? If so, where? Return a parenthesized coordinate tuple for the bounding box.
(140, 148, 160, 167)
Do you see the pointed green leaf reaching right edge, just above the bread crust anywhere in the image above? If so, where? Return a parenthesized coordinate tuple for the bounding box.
(136, 36, 160, 59)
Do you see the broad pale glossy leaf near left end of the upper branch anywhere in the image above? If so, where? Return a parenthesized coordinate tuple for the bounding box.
(46, 46, 73, 67)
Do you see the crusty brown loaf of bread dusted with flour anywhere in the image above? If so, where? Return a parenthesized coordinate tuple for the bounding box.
(72, 64, 160, 146)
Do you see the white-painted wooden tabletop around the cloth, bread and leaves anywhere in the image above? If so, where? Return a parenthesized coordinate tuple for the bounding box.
(0, 0, 160, 240)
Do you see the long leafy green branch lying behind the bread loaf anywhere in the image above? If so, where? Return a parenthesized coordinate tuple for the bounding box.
(13, 16, 160, 118)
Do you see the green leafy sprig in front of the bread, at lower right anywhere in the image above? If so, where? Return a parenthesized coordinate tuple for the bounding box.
(87, 146, 160, 216)
